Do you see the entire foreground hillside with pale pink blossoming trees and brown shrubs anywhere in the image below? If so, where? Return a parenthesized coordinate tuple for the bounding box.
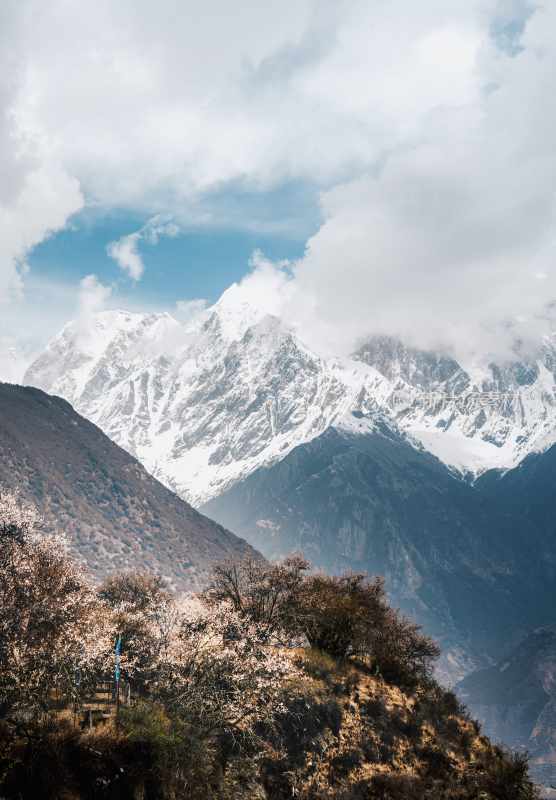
(0, 500, 538, 800)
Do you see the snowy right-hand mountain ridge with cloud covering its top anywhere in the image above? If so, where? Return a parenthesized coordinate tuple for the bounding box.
(355, 337, 556, 475)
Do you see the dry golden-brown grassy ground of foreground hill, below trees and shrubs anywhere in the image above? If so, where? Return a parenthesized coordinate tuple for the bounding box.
(4, 650, 537, 800)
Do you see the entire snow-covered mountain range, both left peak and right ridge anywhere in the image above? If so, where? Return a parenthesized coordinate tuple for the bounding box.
(24, 286, 556, 504)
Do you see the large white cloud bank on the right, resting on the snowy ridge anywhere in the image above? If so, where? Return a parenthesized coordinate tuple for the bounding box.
(226, 7, 556, 359)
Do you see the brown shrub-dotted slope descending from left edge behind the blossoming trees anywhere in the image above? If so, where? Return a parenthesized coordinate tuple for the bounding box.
(0, 384, 253, 588)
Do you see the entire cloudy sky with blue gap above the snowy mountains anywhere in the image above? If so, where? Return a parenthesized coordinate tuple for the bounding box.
(0, 0, 556, 377)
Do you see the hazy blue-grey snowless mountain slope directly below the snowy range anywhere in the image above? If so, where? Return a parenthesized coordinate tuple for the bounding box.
(203, 418, 553, 675)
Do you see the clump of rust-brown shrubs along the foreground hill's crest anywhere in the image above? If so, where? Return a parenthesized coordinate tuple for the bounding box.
(203, 556, 440, 688)
